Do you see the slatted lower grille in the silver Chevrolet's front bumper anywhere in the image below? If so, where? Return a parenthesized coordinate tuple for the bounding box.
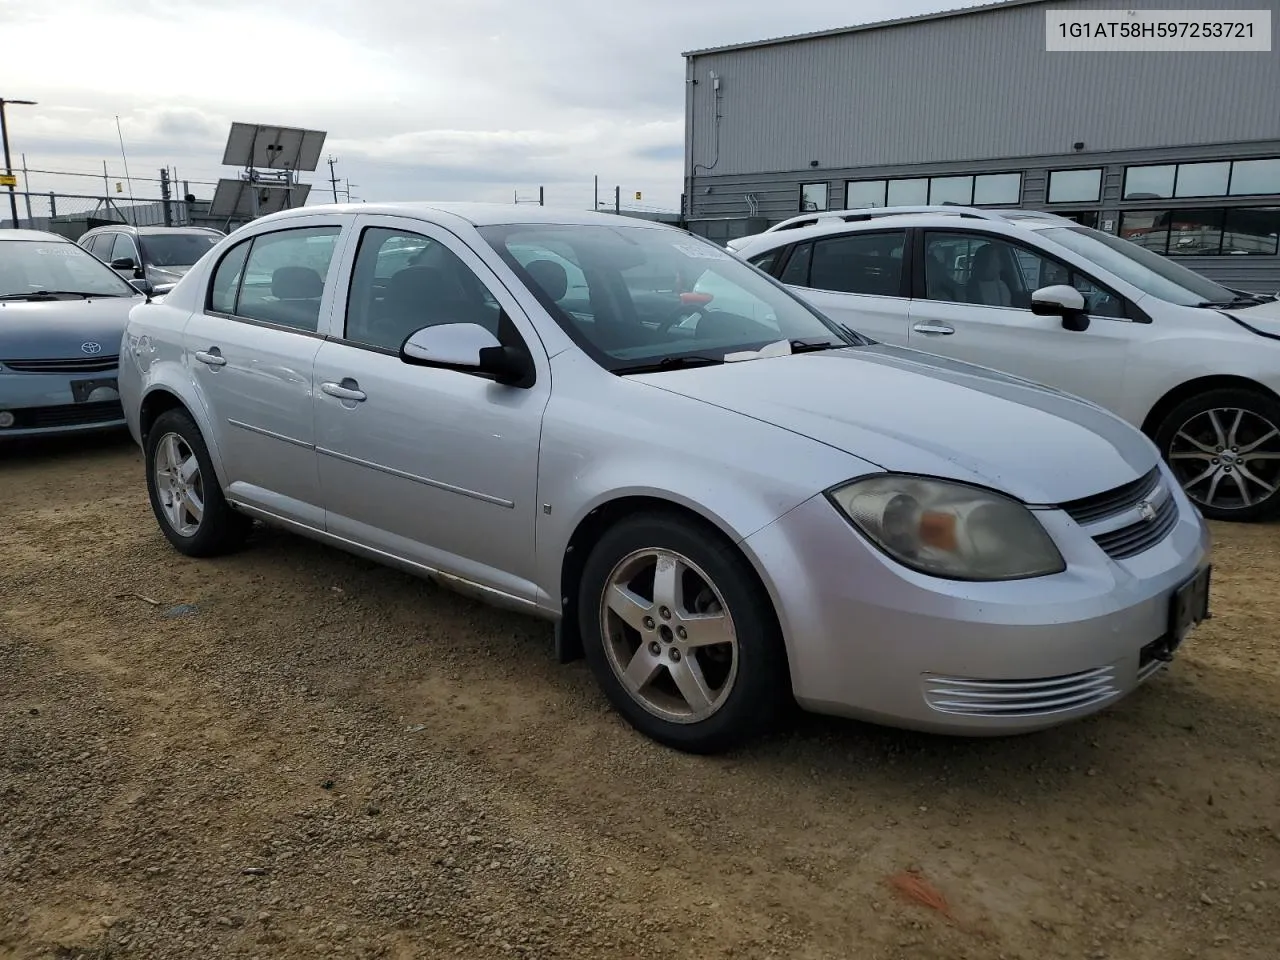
(924, 667, 1120, 717)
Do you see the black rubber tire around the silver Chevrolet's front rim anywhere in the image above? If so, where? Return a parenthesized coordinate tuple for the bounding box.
(577, 512, 791, 754)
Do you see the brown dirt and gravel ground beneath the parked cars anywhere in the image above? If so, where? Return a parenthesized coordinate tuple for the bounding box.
(0, 439, 1280, 960)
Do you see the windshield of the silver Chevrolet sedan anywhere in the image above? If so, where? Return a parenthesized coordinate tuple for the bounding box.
(480, 224, 869, 372)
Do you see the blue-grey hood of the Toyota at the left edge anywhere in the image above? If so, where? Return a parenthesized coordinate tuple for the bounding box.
(0, 297, 143, 362)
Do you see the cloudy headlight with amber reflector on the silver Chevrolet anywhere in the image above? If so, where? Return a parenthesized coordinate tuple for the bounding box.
(827, 474, 1066, 580)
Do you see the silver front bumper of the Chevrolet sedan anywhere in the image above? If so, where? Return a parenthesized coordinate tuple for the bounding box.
(744, 489, 1210, 736)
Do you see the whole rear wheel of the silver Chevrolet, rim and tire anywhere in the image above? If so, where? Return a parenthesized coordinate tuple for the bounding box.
(146, 410, 253, 557)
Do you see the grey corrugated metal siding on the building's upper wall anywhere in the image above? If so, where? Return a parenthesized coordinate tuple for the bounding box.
(690, 0, 1280, 174)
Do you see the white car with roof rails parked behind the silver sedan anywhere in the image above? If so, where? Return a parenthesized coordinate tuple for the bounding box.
(735, 207, 1280, 521)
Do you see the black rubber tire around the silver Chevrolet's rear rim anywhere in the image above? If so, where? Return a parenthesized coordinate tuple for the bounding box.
(145, 410, 253, 557)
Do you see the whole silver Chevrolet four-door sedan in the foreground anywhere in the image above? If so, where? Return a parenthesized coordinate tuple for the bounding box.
(119, 204, 1210, 753)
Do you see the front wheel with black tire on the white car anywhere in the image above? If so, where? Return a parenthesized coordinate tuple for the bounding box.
(1155, 388, 1280, 522)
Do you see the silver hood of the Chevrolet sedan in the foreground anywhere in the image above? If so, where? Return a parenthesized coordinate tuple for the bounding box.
(634, 344, 1158, 504)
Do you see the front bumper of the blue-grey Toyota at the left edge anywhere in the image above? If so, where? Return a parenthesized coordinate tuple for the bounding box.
(0, 369, 124, 442)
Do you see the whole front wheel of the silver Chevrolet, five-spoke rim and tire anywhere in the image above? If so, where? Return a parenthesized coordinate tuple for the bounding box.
(579, 513, 788, 753)
